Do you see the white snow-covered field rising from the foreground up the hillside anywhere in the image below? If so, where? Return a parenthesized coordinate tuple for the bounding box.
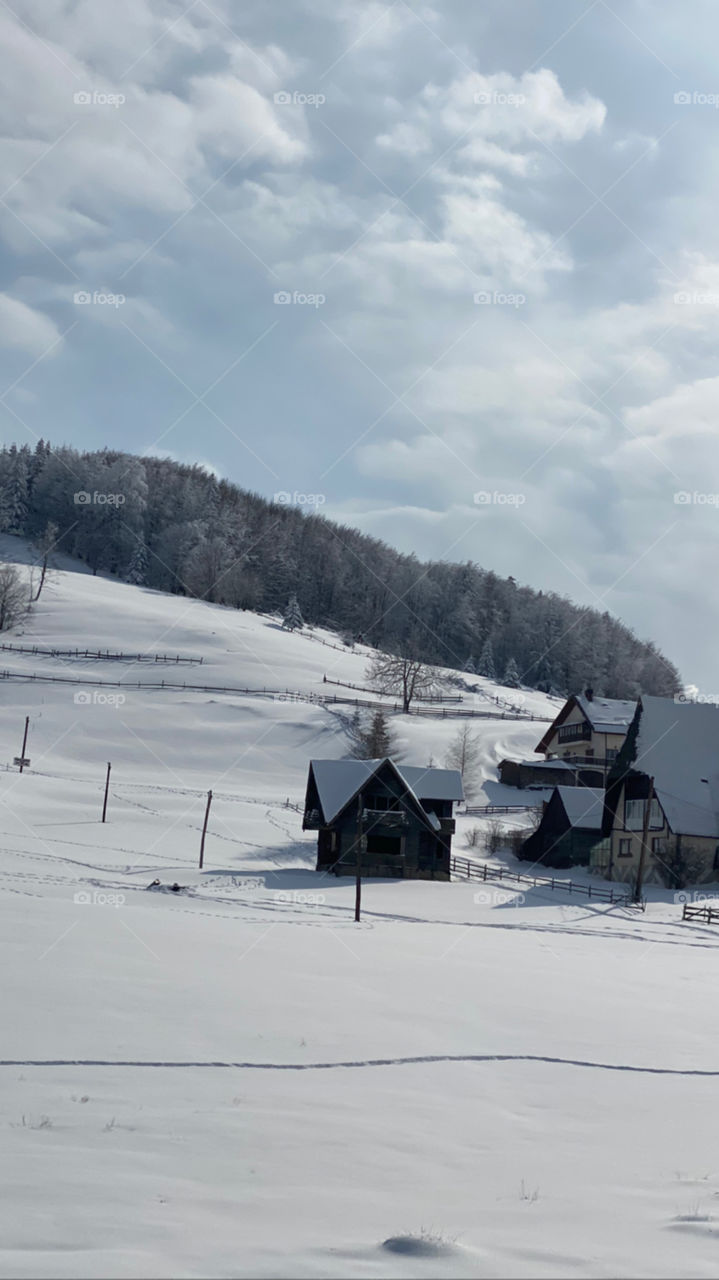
(0, 541, 719, 1277)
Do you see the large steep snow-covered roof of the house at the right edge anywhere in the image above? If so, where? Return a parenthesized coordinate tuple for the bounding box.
(632, 698, 719, 837)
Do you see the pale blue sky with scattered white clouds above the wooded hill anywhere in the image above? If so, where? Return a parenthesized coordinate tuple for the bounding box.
(0, 0, 719, 696)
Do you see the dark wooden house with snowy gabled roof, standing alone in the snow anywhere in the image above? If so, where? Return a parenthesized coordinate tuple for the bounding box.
(302, 759, 463, 879)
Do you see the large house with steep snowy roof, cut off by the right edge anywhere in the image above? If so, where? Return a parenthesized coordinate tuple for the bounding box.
(591, 696, 719, 888)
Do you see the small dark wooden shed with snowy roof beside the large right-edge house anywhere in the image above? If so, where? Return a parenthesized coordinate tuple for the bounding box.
(518, 786, 604, 867)
